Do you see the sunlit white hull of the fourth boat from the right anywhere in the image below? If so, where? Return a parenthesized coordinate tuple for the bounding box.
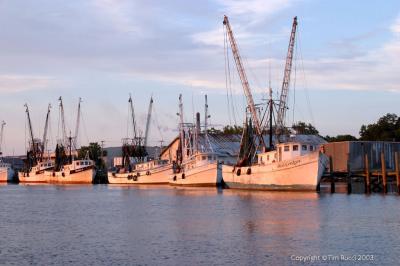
(44, 168, 96, 184)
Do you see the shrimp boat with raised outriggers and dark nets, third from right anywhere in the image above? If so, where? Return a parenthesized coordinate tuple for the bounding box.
(108, 96, 172, 184)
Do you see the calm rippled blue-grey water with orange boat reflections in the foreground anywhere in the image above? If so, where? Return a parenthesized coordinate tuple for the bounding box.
(0, 185, 400, 265)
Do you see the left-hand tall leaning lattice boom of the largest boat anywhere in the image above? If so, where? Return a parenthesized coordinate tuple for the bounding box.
(223, 16, 265, 149)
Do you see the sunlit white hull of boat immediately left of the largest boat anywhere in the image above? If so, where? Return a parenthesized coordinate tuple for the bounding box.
(169, 162, 222, 186)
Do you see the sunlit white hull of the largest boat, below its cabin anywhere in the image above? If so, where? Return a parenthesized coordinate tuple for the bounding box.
(222, 152, 328, 191)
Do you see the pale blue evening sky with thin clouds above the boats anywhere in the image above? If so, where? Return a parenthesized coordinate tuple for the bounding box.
(0, 0, 400, 155)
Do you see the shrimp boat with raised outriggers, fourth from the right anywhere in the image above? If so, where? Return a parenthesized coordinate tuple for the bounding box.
(44, 97, 96, 184)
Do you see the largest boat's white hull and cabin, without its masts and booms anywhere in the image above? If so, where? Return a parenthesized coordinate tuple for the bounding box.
(222, 135, 329, 191)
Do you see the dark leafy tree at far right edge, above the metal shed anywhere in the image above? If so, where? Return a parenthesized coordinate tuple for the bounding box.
(360, 113, 400, 141)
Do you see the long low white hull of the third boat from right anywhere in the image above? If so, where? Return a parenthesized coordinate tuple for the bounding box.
(108, 166, 172, 185)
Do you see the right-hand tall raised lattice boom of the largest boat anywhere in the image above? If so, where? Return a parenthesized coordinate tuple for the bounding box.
(276, 17, 297, 137)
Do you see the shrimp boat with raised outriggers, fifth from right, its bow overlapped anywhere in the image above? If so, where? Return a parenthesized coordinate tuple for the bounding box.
(18, 104, 54, 183)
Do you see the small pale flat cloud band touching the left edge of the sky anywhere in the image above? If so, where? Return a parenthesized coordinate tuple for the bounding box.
(0, 75, 55, 93)
